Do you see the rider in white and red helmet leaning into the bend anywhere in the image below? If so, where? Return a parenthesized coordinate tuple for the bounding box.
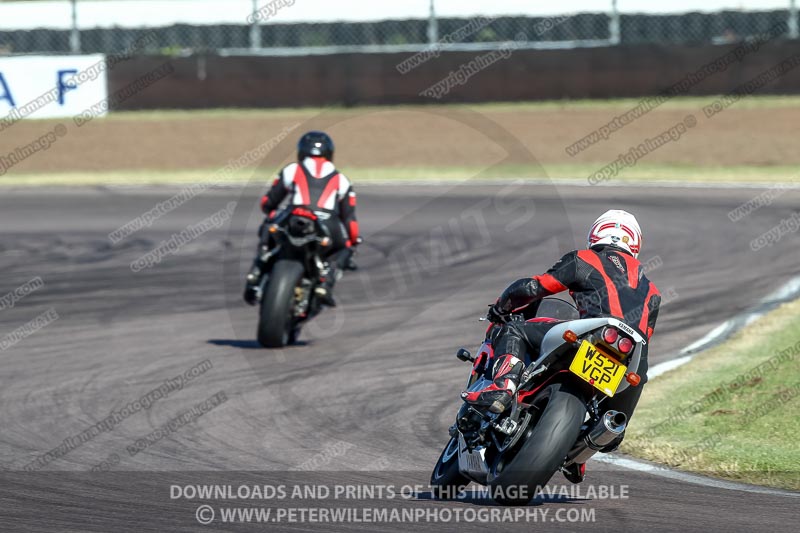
(462, 210, 661, 483)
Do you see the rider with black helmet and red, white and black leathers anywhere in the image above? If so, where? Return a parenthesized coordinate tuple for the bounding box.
(244, 131, 361, 307)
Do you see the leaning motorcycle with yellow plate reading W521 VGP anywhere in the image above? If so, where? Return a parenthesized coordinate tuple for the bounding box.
(431, 298, 647, 505)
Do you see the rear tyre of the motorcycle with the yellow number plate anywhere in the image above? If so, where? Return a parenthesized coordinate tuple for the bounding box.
(489, 383, 587, 505)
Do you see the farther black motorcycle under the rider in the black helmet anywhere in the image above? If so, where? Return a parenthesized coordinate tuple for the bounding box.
(250, 207, 341, 348)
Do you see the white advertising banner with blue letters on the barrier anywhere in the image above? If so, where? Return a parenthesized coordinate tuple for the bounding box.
(0, 54, 108, 123)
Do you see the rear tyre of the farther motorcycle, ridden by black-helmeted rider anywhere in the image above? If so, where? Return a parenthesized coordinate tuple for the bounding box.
(258, 259, 304, 348)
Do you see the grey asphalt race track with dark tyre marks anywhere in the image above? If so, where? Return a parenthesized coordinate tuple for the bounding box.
(0, 183, 800, 532)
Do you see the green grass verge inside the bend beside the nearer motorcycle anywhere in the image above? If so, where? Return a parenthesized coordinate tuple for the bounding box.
(622, 301, 800, 490)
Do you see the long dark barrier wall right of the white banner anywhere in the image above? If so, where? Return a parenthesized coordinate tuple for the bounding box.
(109, 41, 800, 109)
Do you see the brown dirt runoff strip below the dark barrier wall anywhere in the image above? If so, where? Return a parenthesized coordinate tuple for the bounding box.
(0, 102, 800, 179)
